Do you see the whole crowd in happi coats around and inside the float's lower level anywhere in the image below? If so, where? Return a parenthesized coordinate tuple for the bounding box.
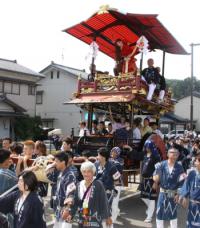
(0, 117, 200, 228)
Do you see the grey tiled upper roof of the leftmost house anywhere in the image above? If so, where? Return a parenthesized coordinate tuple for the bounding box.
(0, 59, 44, 77)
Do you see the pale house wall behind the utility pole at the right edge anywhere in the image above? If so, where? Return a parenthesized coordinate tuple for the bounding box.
(174, 91, 200, 131)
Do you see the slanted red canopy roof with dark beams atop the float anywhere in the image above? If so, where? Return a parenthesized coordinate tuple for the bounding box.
(63, 9, 188, 58)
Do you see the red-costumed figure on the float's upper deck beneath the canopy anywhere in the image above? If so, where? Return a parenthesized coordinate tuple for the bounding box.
(114, 39, 137, 76)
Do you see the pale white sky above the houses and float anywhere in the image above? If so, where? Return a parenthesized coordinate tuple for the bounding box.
(0, 0, 200, 80)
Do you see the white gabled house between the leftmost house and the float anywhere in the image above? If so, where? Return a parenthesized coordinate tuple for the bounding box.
(36, 62, 87, 135)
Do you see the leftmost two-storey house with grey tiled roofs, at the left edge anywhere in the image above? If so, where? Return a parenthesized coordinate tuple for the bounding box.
(0, 59, 44, 138)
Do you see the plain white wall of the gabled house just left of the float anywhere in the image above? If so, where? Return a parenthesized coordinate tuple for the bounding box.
(36, 69, 81, 135)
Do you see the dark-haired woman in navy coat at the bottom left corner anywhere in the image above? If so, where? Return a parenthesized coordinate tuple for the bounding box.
(0, 171, 46, 228)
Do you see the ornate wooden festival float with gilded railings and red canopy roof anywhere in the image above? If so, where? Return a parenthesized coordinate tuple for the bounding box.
(63, 5, 187, 185)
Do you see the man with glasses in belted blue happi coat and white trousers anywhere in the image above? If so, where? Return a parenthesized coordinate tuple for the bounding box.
(153, 148, 186, 228)
